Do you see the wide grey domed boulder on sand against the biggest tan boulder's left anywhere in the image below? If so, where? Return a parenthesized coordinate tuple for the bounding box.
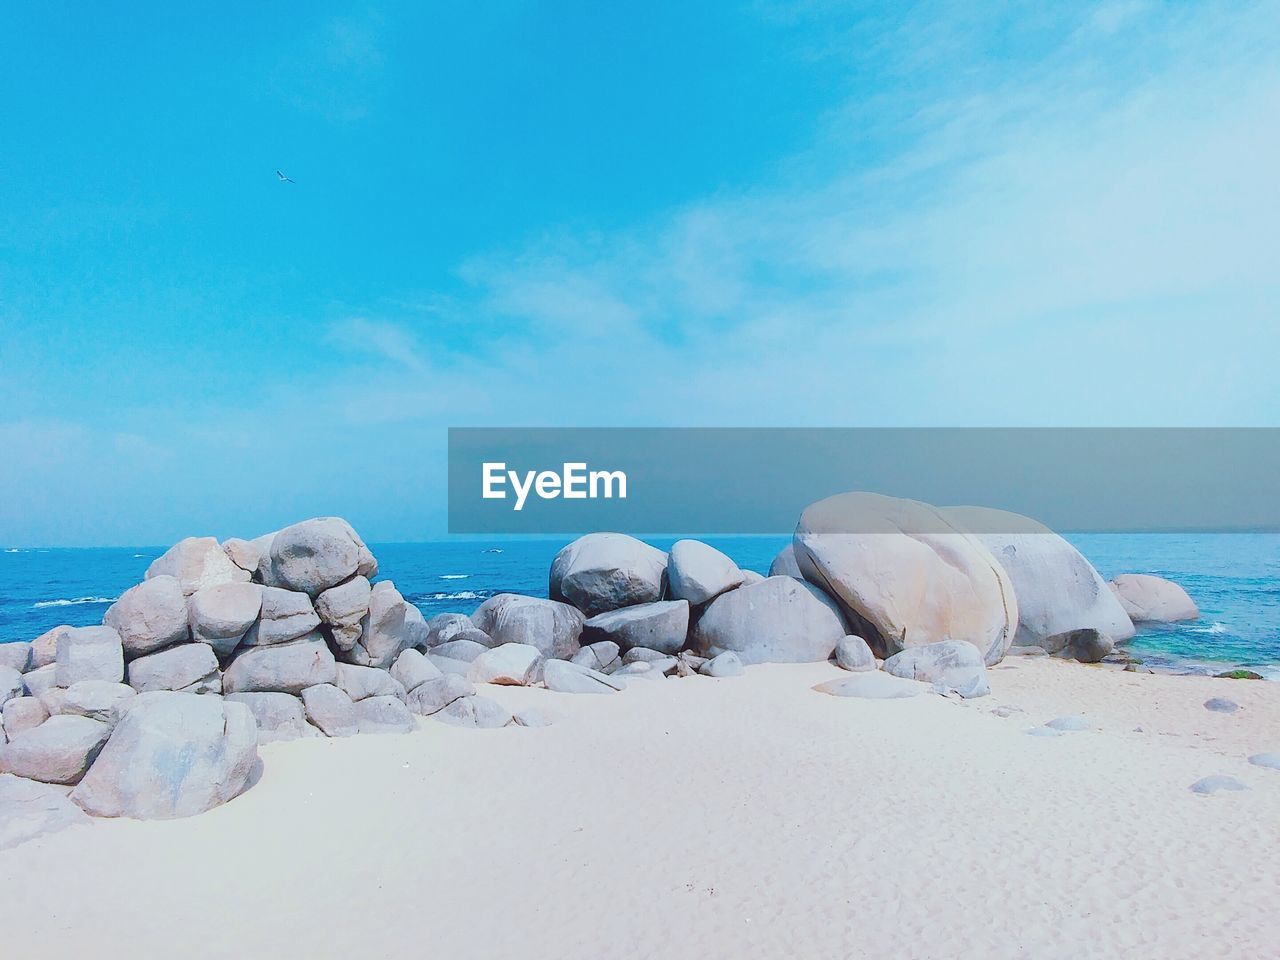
(696, 577, 849, 663)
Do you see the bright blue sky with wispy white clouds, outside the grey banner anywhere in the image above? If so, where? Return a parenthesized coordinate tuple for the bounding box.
(0, 0, 1280, 544)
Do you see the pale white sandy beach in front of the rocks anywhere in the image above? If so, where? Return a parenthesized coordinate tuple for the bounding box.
(0, 659, 1280, 960)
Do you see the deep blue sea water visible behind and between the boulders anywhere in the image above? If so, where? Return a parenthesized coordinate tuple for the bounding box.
(0, 534, 1280, 678)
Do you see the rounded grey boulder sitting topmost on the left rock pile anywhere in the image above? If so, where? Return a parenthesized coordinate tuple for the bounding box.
(265, 517, 378, 596)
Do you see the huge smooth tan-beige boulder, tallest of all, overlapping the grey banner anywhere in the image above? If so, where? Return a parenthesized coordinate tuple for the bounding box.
(792, 493, 1018, 664)
